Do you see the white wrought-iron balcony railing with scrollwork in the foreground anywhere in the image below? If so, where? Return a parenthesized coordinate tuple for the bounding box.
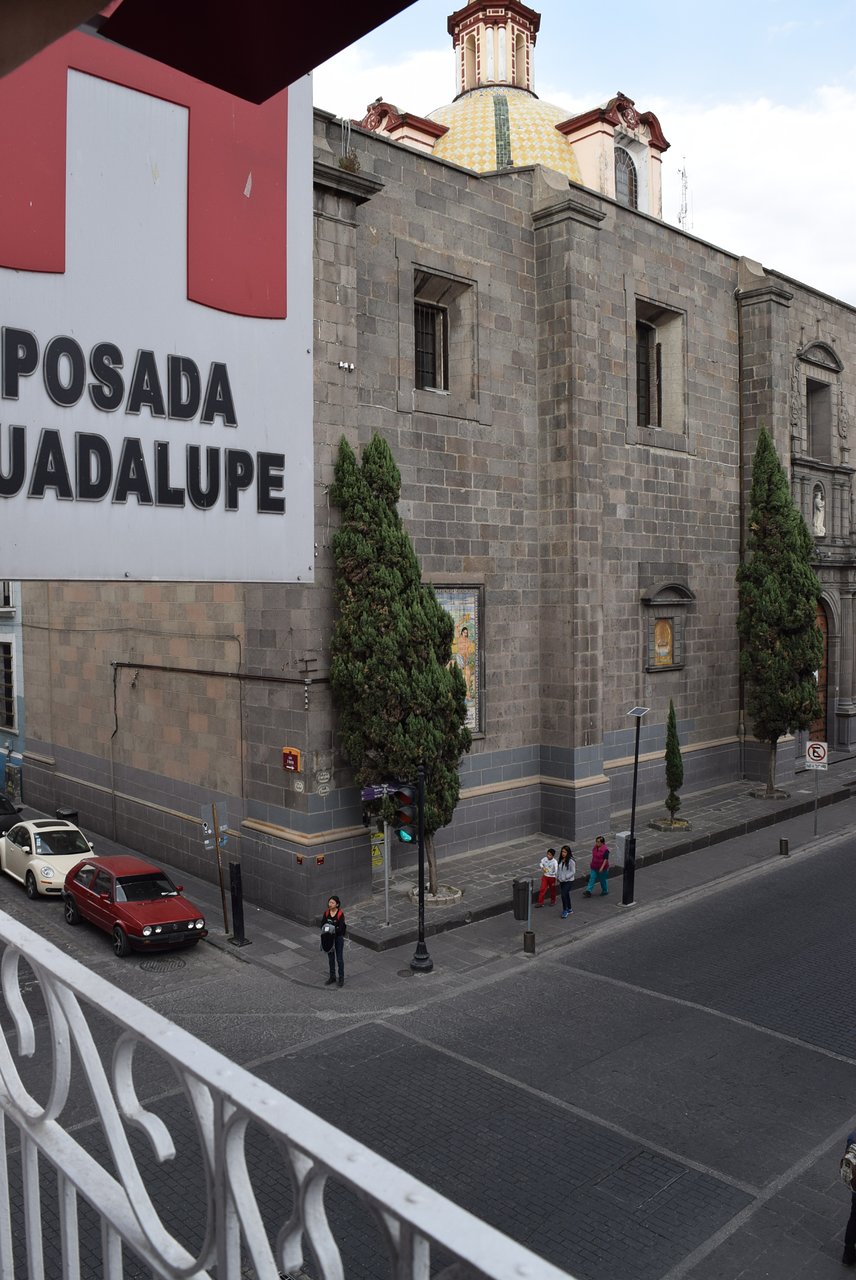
(0, 913, 578, 1280)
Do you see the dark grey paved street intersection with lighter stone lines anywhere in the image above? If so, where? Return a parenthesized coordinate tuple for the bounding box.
(0, 800, 856, 1280)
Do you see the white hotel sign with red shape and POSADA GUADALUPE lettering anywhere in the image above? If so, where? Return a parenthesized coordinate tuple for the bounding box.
(0, 33, 315, 582)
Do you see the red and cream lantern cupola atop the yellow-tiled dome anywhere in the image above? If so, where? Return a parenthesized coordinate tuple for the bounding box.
(449, 0, 541, 97)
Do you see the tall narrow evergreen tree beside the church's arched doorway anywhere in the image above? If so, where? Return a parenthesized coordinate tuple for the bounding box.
(737, 428, 823, 795)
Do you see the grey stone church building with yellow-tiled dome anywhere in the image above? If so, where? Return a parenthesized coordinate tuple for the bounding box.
(15, 0, 856, 919)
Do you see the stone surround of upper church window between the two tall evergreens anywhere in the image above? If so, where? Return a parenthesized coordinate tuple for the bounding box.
(624, 275, 696, 453)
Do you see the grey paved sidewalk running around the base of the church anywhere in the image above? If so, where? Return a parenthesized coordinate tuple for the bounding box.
(155, 759, 856, 972)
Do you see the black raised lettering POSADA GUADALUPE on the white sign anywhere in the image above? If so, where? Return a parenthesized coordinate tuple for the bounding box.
(0, 326, 285, 515)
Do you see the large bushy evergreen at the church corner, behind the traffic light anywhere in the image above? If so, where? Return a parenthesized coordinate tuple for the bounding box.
(330, 435, 472, 893)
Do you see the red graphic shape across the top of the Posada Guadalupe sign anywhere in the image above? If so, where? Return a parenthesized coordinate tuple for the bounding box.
(0, 32, 289, 319)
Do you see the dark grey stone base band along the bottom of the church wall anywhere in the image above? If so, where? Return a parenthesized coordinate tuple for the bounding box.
(24, 742, 752, 923)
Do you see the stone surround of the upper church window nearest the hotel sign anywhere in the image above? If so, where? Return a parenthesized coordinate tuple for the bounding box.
(395, 239, 493, 425)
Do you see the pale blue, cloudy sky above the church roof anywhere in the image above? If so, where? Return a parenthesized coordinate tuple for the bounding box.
(313, 0, 856, 305)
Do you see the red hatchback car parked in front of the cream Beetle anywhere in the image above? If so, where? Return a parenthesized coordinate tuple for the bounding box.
(63, 854, 207, 956)
